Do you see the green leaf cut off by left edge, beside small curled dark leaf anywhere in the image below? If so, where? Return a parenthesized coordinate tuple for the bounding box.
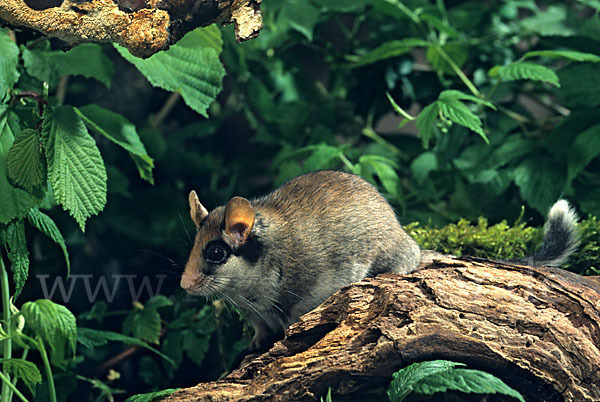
(0, 104, 35, 223)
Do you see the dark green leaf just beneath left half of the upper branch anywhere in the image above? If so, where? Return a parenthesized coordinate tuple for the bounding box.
(21, 42, 115, 88)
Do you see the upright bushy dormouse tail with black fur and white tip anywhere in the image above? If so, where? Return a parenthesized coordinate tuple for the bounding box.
(515, 200, 579, 267)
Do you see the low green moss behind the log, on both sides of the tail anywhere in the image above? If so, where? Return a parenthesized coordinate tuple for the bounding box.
(405, 216, 600, 275)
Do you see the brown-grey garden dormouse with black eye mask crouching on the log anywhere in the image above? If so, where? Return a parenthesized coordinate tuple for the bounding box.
(181, 171, 577, 350)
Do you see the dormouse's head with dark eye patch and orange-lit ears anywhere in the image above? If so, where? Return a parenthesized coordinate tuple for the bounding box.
(181, 191, 259, 295)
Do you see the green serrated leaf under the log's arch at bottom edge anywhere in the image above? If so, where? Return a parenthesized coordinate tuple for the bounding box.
(413, 369, 525, 402)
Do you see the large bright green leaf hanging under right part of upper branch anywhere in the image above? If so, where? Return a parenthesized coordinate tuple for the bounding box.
(115, 25, 225, 117)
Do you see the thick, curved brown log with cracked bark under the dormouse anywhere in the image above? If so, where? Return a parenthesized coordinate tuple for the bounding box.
(168, 257, 600, 402)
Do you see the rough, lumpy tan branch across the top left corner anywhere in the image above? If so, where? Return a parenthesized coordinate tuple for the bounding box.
(0, 0, 262, 57)
